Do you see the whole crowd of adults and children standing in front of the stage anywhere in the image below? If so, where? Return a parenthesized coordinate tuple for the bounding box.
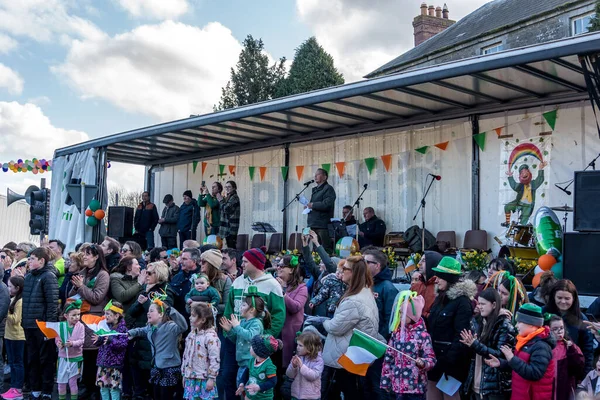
(0, 231, 600, 400)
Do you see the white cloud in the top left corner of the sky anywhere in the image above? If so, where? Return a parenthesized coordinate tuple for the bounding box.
(0, 0, 104, 42)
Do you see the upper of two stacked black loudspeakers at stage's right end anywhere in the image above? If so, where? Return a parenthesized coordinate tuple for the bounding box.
(573, 171, 600, 232)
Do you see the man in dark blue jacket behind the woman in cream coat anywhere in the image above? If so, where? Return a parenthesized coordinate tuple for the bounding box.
(362, 248, 398, 399)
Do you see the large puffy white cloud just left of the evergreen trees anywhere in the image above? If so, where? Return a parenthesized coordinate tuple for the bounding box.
(52, 21, 241, 120)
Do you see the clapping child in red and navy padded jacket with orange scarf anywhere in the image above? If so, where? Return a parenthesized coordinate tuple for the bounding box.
(485, 303, 555, 400)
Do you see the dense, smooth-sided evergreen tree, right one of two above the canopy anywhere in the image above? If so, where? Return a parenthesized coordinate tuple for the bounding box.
(276, 37, 344, 97)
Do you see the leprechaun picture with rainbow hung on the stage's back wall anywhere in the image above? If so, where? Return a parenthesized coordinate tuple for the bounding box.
(501, 139, 549, 226)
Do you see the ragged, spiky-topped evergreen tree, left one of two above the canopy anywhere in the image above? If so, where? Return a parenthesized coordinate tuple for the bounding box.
(214, 35, 285, 111)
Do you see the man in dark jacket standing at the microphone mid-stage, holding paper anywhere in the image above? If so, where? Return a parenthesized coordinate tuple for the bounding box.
(306, 168, 335, 253)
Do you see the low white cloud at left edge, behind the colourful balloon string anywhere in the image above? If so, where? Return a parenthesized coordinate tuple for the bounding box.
(0, 101, 88, 193)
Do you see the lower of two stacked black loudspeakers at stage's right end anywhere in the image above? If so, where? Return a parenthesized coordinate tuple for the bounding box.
(563, 232, 600, 296)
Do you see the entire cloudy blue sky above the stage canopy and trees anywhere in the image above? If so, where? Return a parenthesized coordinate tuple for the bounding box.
(0, 0, 487, 193)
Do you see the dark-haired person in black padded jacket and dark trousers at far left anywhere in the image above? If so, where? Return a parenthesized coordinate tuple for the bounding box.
(21, 247, 58, 399)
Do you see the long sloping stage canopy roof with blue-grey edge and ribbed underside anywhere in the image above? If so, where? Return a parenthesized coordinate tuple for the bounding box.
(55, 33, 600, 166)
